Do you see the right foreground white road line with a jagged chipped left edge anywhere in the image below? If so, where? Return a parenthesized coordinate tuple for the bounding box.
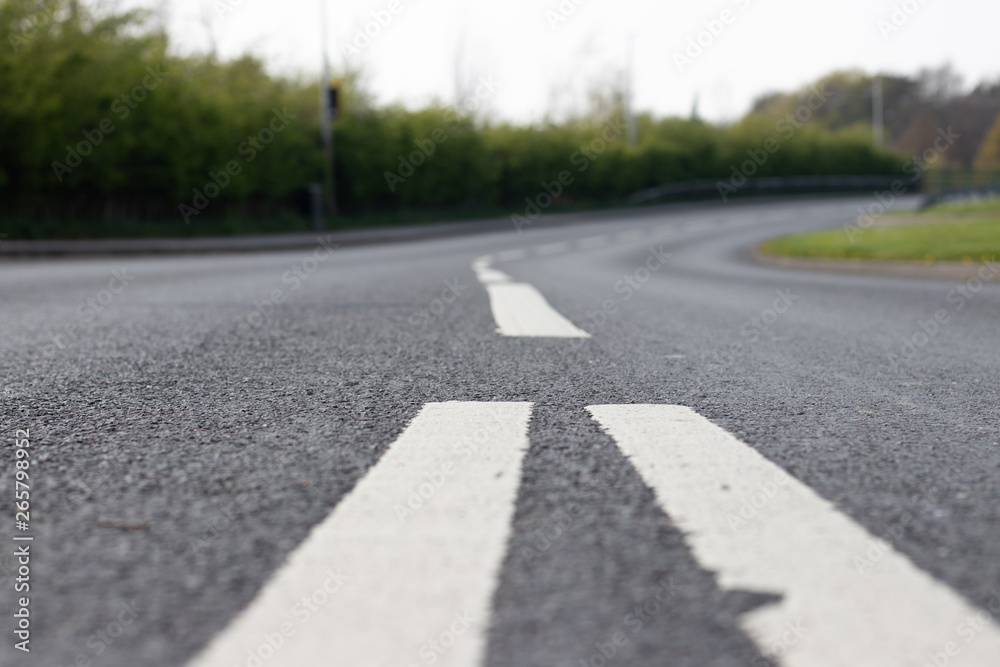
(587, 405, 1000, 667)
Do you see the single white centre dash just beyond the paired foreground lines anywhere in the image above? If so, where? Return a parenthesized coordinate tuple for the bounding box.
(486, 283, 590, 338)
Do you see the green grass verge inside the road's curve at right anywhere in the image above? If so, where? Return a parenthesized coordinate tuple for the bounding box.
(760, 199, 1000, 263)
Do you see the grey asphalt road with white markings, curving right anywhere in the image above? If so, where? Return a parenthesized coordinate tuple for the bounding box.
(0, 199, 1000, 667)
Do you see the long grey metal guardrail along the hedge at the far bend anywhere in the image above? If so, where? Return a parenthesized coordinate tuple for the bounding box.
(624, 175, 920, 206)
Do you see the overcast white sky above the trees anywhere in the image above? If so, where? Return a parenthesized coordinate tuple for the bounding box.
(125, 0, 1000, 121)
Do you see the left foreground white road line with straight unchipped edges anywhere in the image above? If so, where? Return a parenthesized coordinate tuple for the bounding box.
(192, 403, 532, 667)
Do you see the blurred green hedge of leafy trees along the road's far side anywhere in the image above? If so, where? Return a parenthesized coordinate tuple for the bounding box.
(0, 0, 928, 236)
